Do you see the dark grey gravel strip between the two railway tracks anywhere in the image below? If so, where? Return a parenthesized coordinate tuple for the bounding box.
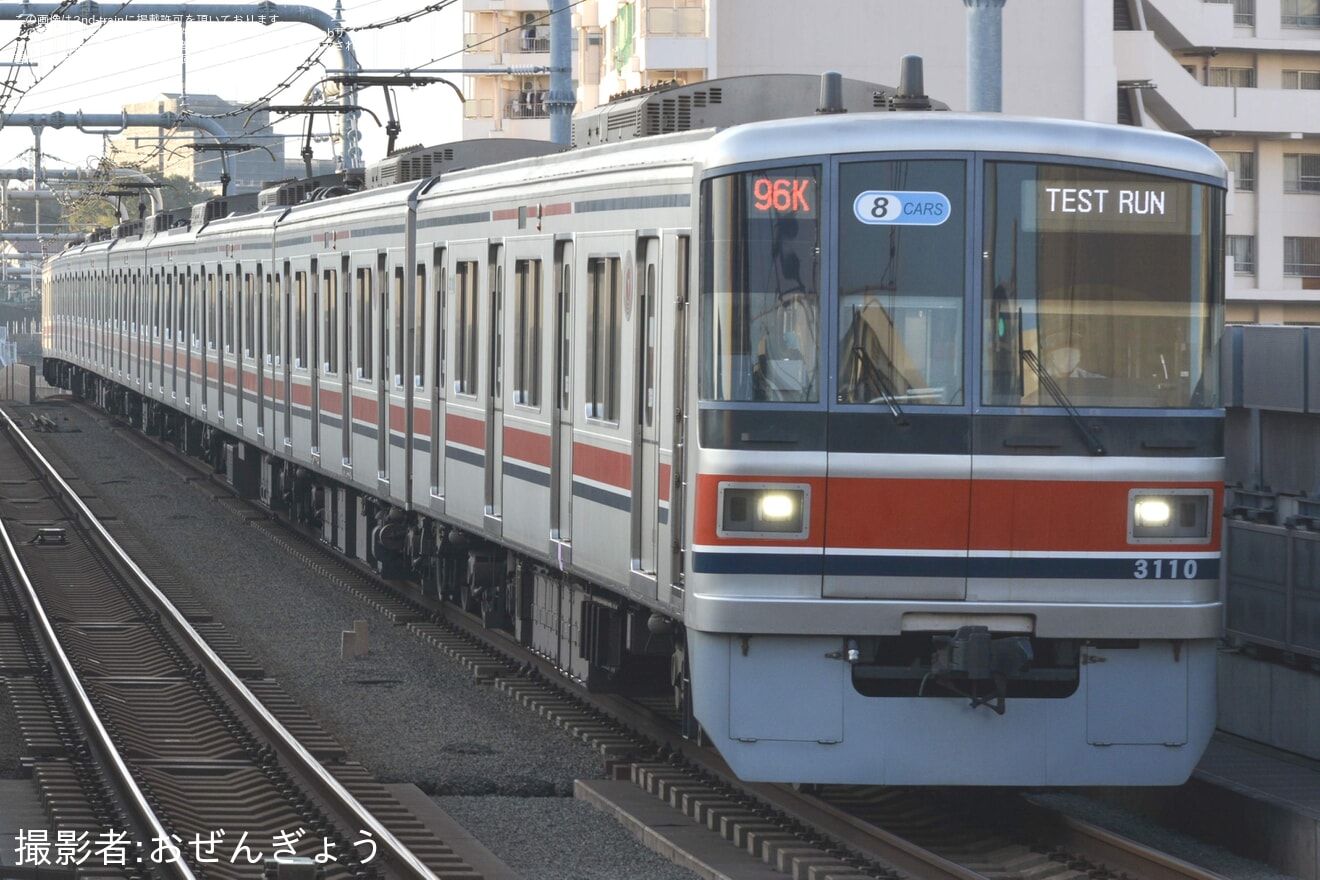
(23, 404, 696, 880)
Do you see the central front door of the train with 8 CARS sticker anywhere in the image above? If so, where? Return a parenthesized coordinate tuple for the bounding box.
(823, 158, 974, 600)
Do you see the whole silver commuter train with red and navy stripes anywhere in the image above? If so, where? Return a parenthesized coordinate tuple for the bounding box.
(42, 67, 1226, 786)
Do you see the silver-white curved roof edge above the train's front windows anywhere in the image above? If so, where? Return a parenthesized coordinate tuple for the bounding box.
(704, 112, 1228, 183)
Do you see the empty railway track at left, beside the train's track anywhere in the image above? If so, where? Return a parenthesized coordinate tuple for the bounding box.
(0, 416, 479, 880)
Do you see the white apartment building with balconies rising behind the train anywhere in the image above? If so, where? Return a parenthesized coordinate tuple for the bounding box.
(463, 0, 1320, 323)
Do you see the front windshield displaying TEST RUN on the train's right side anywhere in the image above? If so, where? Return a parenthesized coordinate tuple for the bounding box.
(982, 162, 1224, 408)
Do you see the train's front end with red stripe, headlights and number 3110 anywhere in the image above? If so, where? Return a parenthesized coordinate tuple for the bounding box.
(684, 113, 1224, 785)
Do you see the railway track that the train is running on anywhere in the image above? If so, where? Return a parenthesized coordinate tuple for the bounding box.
(12, 403, 1235, 880)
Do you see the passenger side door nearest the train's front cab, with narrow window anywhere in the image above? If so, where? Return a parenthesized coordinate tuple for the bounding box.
(624, 237, 660, 588)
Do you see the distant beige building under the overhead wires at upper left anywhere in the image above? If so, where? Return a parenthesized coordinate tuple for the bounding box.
(110, 94, 286, 193)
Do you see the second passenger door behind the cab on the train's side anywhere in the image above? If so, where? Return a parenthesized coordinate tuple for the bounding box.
(550, 241, 573, 544)
